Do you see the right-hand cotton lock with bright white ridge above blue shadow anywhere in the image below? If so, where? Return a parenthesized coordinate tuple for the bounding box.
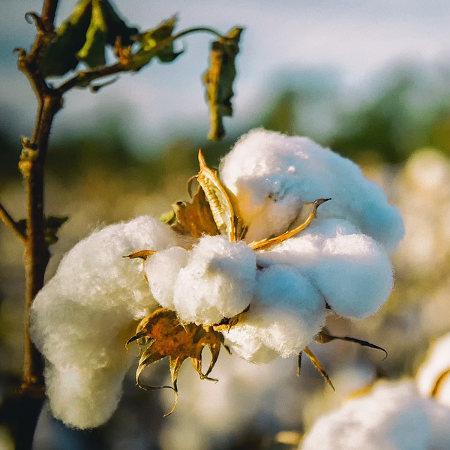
(258, 219, 393, 318)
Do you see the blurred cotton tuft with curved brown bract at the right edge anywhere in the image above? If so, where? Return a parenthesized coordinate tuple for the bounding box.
(416, 333, 450, 407)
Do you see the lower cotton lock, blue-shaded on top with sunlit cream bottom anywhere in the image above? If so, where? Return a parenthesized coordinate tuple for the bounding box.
(224, 265, 325, 362)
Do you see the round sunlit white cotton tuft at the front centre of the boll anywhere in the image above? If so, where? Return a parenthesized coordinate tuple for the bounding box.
(174, 236, 256, 324)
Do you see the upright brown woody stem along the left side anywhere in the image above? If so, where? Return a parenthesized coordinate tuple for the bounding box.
(0, 0, 62, 450)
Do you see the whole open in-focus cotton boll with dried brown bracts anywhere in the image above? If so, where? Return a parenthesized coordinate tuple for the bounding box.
(32, 129, 403, 428)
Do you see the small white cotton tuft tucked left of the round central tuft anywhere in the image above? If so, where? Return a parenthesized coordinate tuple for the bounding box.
(144, 247, 188, 309)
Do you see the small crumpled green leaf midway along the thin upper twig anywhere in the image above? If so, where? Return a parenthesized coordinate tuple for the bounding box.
(129, 16, 183, 71)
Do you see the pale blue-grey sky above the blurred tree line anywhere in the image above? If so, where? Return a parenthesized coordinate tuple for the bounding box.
(0, 0, 450, 146)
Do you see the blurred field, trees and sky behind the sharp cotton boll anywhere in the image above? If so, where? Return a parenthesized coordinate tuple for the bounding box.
(0, 0, 450, 450)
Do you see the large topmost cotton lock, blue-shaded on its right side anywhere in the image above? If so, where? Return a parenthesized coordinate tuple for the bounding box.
(220, 129, 404, 250)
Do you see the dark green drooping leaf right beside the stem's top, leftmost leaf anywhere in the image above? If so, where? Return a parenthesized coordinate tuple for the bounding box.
(39, 0, 92, 77)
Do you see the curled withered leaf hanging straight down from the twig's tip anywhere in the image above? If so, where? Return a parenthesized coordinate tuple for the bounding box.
(203, 27, 243, 140)
